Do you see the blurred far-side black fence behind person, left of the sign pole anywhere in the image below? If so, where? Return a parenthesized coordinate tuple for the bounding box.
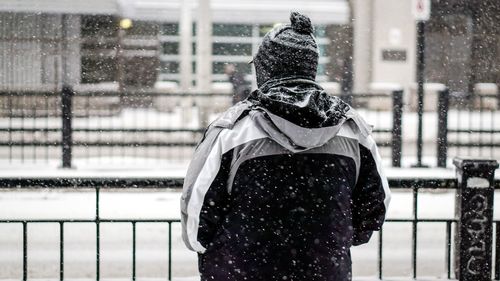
(0, 88, 403, 167)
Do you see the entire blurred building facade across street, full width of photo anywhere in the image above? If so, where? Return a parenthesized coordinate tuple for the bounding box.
(0, 0, 500, 98)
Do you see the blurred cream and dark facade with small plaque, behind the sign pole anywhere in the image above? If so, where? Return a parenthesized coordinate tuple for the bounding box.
(360, 0, 500, 97)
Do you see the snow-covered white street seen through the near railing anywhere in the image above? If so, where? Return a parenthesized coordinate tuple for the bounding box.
(0, 166, 500, 280)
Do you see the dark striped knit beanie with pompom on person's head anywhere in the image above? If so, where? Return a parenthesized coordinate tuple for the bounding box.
(253, 12, 319, 87)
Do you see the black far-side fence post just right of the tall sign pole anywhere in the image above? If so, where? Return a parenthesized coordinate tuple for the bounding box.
(437, 88, 450, 168)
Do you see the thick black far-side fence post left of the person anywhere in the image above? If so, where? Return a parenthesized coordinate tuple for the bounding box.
(61, 85, 73, 168)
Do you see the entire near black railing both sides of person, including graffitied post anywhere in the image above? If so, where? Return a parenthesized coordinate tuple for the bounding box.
(0, 156, 500, 280)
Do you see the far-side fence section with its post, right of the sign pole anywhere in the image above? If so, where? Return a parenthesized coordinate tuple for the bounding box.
(437, 89, 500, 167)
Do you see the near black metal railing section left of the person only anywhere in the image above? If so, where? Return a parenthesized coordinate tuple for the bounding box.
(0, 177, 183, 281)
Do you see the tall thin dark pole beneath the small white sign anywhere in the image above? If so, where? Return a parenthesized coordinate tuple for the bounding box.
(415, 21, 425, 167)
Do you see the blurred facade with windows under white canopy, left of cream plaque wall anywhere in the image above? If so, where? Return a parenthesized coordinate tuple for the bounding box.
(0, 0, 349, 92)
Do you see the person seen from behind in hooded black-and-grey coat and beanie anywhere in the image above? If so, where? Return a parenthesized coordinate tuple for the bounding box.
(182, 13, 389, 281)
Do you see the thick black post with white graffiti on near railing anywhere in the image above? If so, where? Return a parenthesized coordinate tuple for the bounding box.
(453, 158, 498, 281)
